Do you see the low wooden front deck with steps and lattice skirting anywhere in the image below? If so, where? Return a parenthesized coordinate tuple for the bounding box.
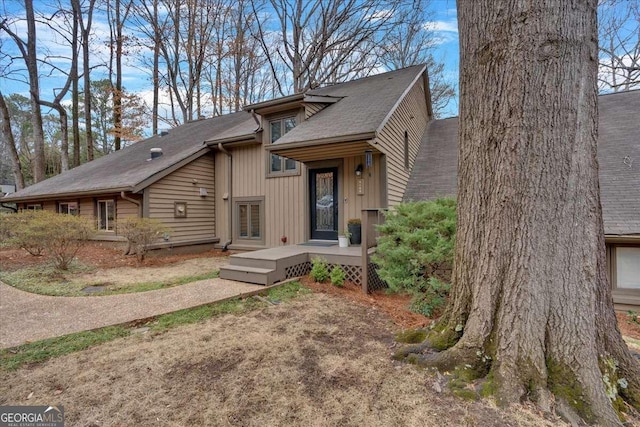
(220, 243, 362, 285)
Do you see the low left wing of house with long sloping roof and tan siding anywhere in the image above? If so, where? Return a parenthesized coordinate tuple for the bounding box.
(0, 112, 256, 245)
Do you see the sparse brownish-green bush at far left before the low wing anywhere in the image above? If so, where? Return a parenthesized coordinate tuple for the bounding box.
(2, 210, 93, 270)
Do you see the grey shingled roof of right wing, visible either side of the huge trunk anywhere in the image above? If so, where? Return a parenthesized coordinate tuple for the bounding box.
(404, 90, 640, 236)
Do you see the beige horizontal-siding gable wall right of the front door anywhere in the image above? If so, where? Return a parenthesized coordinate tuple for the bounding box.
(378, 79, 428, 206)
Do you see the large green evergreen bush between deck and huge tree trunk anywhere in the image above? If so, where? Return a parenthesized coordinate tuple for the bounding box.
(372, 198, 456, 315)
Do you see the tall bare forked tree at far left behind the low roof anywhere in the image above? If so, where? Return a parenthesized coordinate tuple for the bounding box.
(0, 0, 45, 182)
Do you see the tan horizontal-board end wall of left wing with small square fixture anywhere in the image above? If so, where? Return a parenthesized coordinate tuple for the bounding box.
(147, 153, 216, 242)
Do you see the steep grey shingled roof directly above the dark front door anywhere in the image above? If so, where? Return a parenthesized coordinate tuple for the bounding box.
(276, 65, 425, 145)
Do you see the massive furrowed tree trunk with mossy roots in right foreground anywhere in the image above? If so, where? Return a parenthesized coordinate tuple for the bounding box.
(400, 0, 640, 425)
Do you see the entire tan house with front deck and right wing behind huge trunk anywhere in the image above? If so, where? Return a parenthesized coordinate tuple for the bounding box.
(0, 66, 640, 307)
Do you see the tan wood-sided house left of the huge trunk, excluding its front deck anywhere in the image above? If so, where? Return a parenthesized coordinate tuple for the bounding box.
(1, 66, 432, 256)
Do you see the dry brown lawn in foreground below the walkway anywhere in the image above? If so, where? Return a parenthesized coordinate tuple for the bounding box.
(0, 294, 561, 426)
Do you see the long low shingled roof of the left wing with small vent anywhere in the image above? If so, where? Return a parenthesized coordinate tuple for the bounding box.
(2, 112, 257, 202)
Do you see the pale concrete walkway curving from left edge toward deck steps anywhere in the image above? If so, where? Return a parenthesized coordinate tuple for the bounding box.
(0, 279, 265, 349)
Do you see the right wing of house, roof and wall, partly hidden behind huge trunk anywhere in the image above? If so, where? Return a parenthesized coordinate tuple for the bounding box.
(404, 90, 640, 310)
